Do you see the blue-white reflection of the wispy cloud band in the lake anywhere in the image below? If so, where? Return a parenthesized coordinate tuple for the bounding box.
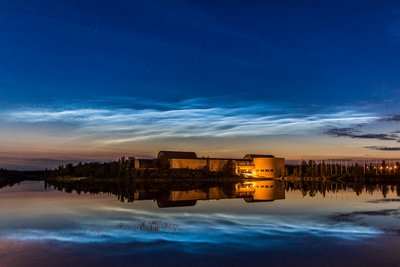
(0, 208, 382, 247)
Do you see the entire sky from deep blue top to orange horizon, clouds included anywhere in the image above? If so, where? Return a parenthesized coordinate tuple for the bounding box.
(0, 0, 400, 169)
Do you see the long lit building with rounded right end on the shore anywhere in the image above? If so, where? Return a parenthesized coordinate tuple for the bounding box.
(154, 151, 285, 178)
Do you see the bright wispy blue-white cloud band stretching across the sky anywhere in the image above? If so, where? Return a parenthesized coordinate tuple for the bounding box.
(0, 99, 378, 144)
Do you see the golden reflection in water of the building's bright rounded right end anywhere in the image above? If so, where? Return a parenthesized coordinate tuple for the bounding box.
(236, 179, 285, 202)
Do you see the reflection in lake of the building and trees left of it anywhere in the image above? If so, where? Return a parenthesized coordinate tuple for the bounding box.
(45, 179, 285, 208)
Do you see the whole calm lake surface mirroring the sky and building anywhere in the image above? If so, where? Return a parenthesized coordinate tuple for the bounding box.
(0, 180, 400, 266)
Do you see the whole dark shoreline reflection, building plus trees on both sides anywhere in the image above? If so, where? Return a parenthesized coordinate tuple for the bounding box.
(37, 179, 400, 208)
